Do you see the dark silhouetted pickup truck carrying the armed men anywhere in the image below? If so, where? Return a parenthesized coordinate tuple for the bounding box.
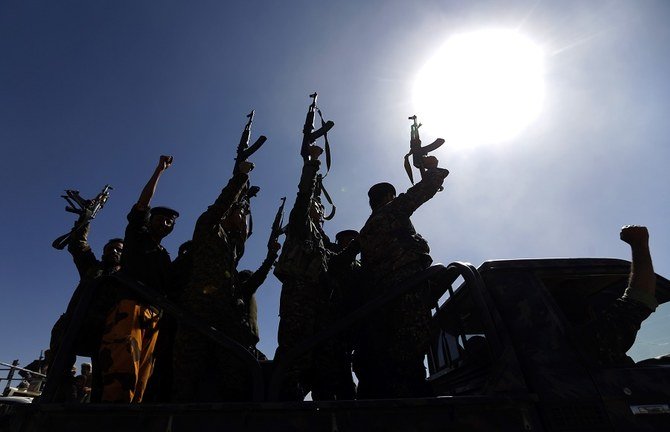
(0, 258, 670, 432)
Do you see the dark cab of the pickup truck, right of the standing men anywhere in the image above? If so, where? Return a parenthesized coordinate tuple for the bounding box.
(428, 259, 670, 431)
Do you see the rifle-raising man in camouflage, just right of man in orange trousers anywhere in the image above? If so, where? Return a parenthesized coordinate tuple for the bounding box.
(173, 160, 253, 402)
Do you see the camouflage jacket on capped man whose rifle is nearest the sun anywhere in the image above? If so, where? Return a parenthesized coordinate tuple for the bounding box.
(358, 169, 447, 283)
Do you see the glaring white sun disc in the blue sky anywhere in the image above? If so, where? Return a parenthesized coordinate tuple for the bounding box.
(413, 30, 544, 146)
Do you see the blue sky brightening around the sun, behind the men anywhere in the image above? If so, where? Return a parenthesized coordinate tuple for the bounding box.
(0, 0, 670, 364)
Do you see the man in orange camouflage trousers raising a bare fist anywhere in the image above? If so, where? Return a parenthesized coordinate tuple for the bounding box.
(100, 156, 179, 403)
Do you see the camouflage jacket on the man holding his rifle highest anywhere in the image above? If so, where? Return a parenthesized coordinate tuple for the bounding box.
(274, 160, 331, 282)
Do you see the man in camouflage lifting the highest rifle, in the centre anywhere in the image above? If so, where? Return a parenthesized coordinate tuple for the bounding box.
(274, 146, 332, 400)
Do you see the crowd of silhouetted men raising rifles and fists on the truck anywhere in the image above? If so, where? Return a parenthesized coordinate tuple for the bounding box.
(43, 138, 655, 403)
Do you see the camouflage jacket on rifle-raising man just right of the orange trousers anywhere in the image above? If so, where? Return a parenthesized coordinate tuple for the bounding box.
(188, 173, 249, 300)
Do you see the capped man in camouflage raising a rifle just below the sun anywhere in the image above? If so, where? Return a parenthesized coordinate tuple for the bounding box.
(354, 156, 449, 398)
